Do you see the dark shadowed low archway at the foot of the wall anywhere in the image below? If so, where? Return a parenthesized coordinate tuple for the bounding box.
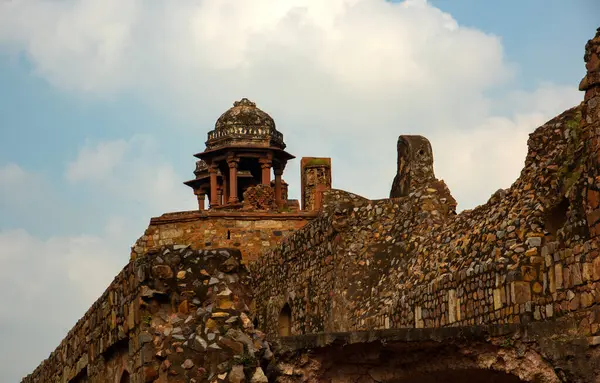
(282, 340, 560, 383)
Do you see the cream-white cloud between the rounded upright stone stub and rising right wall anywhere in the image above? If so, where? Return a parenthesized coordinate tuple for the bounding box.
(430, 85, 581, 209)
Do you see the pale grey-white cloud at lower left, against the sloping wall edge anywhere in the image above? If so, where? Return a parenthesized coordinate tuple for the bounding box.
(0, 229, 132, 382)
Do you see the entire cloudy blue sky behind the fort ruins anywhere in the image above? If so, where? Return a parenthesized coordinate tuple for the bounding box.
(0, 0, 600, 382)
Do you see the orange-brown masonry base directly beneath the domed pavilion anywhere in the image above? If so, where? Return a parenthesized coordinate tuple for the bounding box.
(131, 211, 316, 263)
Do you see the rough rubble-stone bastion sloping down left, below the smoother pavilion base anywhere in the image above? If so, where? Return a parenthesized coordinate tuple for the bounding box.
(23, 246, 272, 383)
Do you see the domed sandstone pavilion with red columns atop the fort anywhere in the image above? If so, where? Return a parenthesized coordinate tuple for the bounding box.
(184, 98, 295, 210)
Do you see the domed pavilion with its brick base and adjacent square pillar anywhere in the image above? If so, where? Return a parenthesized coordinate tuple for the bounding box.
(131, 98, 331, 263)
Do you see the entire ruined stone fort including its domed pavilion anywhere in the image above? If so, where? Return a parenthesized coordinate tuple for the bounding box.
(23, 28, 600, 383)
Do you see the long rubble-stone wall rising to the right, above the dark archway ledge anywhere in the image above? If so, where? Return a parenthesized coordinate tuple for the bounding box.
(254, 97, 600, 341)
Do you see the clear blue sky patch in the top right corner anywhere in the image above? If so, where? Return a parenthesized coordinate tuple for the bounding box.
(430, 0, 600, 90)
